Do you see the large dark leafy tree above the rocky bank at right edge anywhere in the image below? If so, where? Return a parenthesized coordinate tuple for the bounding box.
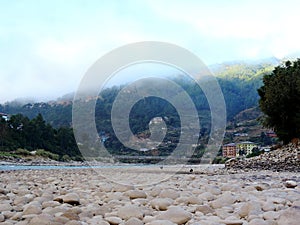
(258, 59, 300, 143)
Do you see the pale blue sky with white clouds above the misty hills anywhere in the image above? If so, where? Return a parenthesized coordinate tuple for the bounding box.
(0, 0, 300, 103)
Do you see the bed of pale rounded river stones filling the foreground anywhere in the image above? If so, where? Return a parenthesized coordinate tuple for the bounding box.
(0, 166, 300, 225)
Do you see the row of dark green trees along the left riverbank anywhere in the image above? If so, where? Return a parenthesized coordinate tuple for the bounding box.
(0, 114, 80, 159)
